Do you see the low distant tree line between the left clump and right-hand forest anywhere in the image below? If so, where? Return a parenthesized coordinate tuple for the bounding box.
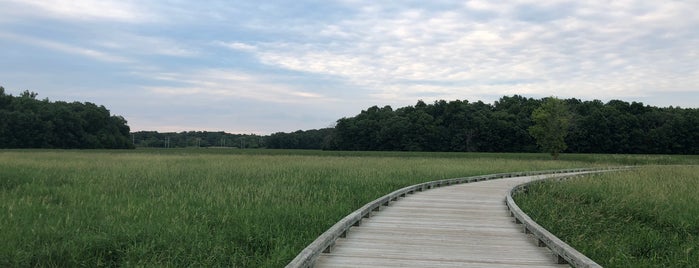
(132, 131, 267, 148)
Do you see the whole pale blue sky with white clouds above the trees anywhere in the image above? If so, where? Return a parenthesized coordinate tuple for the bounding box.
(0, 0, 699, 134)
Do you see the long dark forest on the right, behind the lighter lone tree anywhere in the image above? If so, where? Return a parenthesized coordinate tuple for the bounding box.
(269, 95, 699, 154)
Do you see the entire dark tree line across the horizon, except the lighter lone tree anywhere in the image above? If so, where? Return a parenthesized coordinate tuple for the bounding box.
(0, 87, 699, 154)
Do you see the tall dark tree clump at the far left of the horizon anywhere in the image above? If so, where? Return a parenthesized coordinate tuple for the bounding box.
(0, 87, 133, 149)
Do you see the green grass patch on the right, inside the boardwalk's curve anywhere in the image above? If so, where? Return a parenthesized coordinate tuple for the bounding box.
(515, 166, 699, 267)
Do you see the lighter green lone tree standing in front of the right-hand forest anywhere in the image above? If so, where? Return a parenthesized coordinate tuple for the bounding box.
(529, 97, 570, 159)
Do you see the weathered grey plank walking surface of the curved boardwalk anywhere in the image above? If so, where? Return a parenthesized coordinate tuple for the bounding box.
(315, 173, 572, 267)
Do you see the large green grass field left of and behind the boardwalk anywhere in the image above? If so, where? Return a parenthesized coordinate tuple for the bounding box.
(0, 149, 696, 267)
